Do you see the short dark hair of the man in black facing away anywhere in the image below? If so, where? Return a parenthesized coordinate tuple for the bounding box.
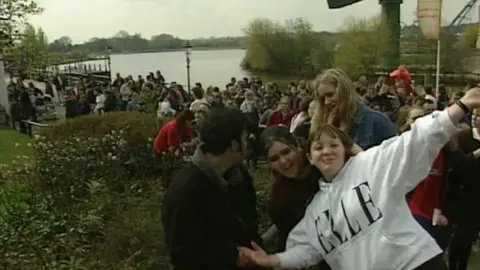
(199, 108, 246, 155)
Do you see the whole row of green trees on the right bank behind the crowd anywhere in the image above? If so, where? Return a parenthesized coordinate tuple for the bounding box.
(242, 15, 476, 78)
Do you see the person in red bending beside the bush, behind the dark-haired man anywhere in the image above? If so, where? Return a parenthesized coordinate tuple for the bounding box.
(153, 110, 194, 153)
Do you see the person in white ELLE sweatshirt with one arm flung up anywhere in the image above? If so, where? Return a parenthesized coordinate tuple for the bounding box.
(239, 89, 480, 270)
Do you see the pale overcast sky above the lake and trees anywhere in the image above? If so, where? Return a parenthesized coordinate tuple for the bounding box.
(30, 0, 477, 42)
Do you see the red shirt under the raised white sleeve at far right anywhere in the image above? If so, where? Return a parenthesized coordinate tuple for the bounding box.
(408, 151, 445, 219)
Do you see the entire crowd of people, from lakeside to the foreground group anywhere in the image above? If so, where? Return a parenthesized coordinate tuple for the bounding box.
(3, 66, 480, 270)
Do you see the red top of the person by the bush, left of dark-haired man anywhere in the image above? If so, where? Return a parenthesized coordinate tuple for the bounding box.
(153, 120, 192, 153)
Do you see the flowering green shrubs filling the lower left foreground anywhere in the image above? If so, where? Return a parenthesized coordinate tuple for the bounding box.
(0, 112, 268, 270)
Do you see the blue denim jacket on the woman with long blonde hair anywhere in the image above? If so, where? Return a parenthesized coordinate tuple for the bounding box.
(349, 104, 396, 150)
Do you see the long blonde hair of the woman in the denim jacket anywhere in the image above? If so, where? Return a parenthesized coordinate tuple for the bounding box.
(310, 68, 362, 133)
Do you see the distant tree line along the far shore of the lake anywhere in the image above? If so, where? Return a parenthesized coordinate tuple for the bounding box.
(49, 30, 244, 54)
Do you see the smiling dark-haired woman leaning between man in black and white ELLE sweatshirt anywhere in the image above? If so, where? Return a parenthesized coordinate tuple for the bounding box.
(261, 126, 329, 269)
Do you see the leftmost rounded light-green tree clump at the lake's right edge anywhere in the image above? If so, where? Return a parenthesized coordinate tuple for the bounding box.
(241, 19, 335, 75)
